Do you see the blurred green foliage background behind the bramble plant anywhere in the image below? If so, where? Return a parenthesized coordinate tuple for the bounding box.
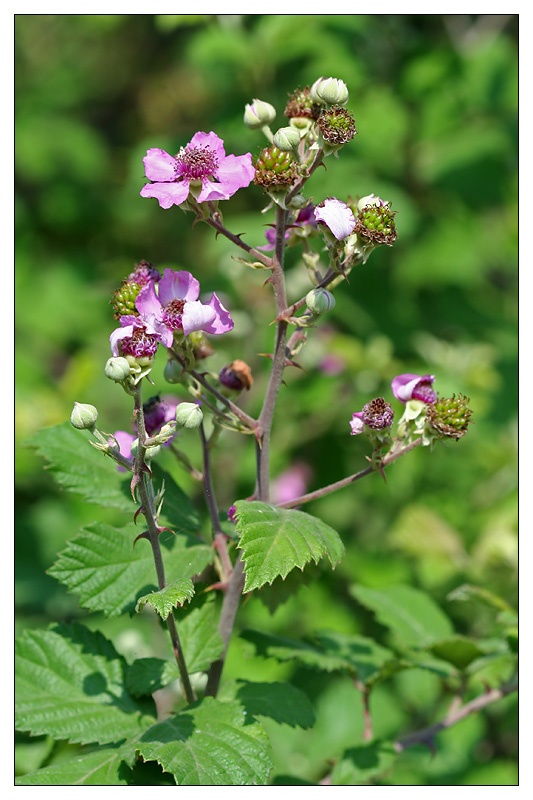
(15, 14, 518, 785)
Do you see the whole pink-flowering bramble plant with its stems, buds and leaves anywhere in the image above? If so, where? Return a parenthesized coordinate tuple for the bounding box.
(16, 78, 517, 786)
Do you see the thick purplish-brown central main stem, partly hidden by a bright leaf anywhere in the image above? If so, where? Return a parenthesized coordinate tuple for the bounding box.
(206, 206, 287, 697)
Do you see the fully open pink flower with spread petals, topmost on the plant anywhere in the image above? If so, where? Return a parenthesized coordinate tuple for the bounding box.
(141, 131, 251, 208)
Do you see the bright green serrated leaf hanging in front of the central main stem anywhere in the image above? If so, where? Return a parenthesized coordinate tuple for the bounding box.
(235, 500, 344, 592)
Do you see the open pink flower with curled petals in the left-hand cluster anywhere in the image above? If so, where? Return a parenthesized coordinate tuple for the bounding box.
(135, 269, 233, 338)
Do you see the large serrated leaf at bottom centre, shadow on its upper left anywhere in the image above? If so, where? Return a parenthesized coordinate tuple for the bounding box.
(138, 697, 272, 786)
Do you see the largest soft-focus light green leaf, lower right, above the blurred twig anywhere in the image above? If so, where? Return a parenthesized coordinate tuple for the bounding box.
(350, 586, 454, 647)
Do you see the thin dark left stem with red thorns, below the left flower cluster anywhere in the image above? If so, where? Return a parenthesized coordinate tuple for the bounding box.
(134, 385, 196, 703)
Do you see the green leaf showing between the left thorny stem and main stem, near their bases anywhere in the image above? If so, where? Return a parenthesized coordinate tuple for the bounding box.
(176, 592, 224, 675)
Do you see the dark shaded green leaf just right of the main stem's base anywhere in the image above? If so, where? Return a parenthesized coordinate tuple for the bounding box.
(233, 680, 315, 728)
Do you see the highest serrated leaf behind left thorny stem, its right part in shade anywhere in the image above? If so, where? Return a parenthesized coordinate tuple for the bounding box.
(29, 422, 200, 533)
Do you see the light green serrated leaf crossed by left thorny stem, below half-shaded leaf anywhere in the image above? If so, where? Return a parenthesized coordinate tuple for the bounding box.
(48, 522, 212, 617)
